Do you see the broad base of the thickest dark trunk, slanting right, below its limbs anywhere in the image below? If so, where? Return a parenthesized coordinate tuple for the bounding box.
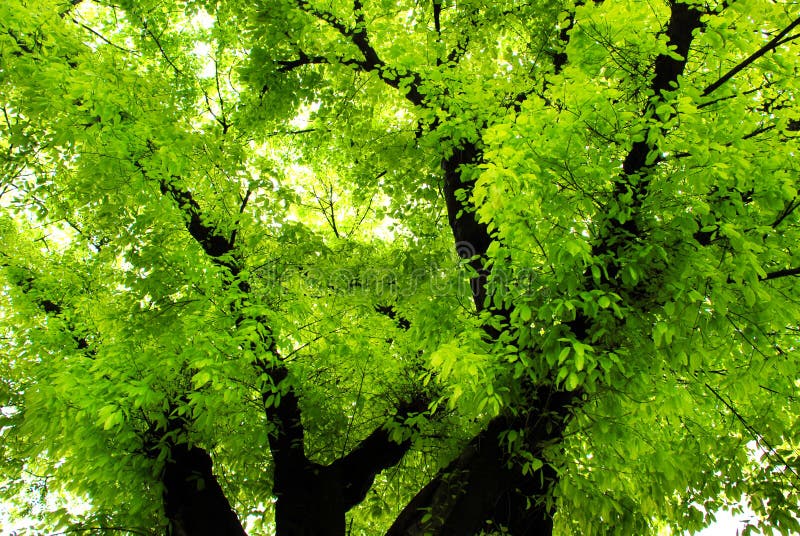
(386, 391, 574, 536)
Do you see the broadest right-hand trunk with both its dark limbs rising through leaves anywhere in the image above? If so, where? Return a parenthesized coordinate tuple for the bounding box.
(387, 2, 700, 536)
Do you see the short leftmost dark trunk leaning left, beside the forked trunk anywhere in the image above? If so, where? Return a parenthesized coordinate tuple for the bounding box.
(162, 444, 246, 536)
